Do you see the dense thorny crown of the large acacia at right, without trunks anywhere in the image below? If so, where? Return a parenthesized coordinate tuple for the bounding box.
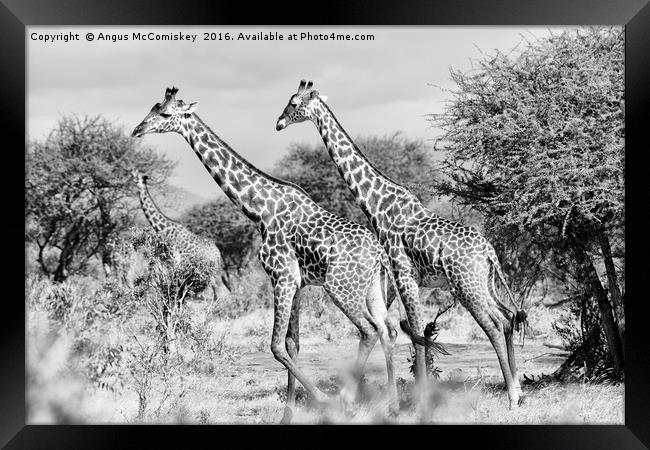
(431, 29, 624, 237)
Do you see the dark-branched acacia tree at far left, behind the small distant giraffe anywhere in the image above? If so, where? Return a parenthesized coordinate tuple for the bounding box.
(25, 116, 173, 281)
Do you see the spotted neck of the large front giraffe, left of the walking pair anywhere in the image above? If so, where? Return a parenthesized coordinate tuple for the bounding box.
(180, 114, 313, 223)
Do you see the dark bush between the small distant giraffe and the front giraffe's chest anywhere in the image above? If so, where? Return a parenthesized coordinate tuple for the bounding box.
(182, 198, 259, 278)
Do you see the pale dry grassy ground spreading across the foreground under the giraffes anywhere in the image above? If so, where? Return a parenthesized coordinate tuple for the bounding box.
(27, 272, 624, 424)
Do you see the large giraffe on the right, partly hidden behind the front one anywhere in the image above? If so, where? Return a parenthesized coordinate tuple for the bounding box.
(276, 80, 525, 408)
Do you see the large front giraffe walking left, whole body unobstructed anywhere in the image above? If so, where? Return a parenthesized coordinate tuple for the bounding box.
(132, 88, 412, 423)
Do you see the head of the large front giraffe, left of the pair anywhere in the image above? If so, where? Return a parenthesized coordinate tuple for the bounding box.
(131, 87, 197, 137)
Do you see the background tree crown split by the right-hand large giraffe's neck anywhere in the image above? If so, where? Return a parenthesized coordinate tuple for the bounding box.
(274, 132, 433, 224)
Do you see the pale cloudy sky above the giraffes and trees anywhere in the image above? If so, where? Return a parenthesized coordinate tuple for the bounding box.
(27, 26, 557, 198)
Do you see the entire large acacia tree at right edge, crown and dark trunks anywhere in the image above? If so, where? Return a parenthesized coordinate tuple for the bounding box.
(430, 28, 625, 376)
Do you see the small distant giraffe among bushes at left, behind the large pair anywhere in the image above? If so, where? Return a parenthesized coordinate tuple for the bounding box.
(131, 169, 230, 299)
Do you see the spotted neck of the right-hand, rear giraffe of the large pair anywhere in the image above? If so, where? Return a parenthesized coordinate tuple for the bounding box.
(312, 99, 425, 220)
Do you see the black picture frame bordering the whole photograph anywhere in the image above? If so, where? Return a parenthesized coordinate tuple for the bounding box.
(0, 0, 650, 449)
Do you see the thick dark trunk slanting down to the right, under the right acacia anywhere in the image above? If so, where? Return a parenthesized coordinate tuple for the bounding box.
(573, 245, 624, 378)
